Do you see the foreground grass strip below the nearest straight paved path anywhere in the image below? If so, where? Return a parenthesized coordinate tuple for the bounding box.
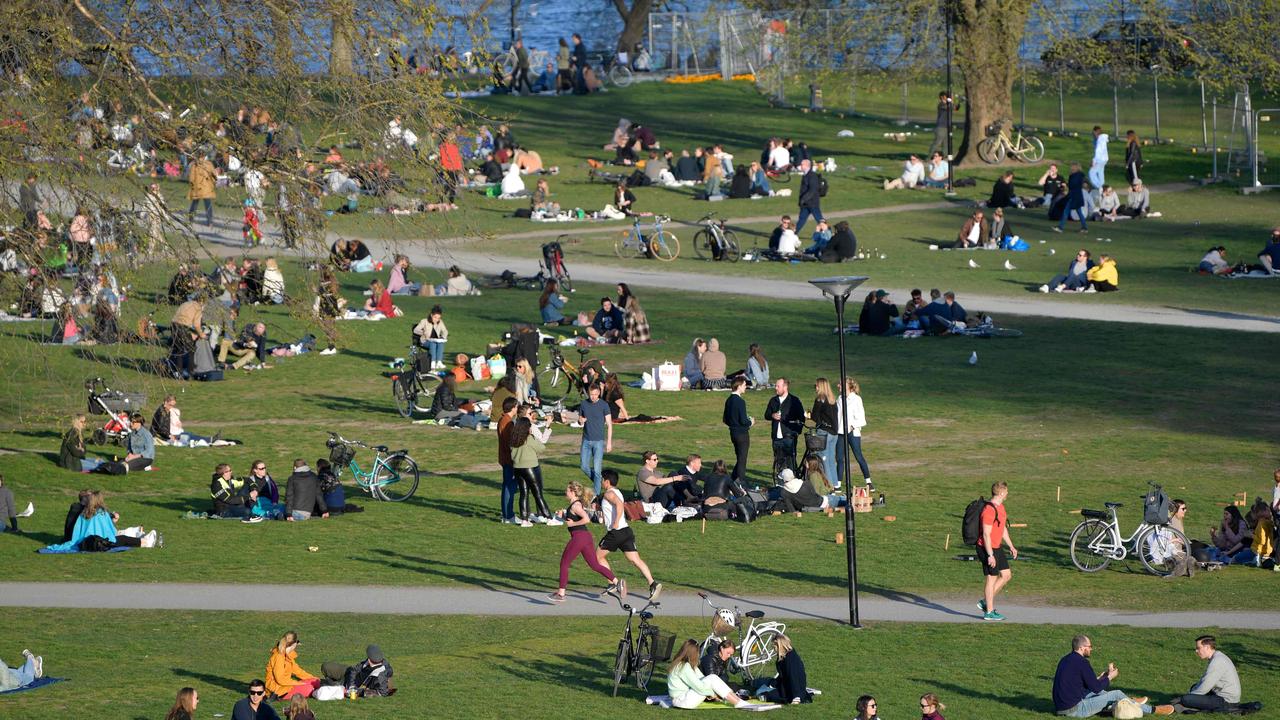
(10, 609, 1280, 720)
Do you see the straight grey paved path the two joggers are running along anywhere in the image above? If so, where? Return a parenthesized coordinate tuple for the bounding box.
(0, 583, 1280, 630)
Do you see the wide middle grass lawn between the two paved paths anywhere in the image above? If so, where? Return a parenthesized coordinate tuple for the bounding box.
(0, 260, 1280, 609)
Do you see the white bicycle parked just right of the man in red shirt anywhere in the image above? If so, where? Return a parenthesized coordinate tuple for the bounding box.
(1070, 483, 1192, 578)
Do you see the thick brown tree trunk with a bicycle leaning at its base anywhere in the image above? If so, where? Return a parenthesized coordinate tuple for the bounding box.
(950, 0, 1032, 165)
